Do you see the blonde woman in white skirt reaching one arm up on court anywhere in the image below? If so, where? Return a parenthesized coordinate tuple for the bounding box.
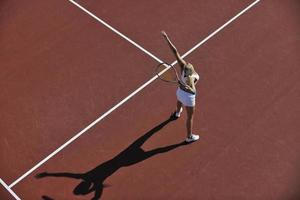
(162, 31, 199, 142)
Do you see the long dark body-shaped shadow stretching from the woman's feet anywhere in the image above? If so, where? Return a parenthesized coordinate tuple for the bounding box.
(36, 115, 187, 200)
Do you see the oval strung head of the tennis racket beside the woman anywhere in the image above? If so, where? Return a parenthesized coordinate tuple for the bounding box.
(155, 62, 181, 84)
